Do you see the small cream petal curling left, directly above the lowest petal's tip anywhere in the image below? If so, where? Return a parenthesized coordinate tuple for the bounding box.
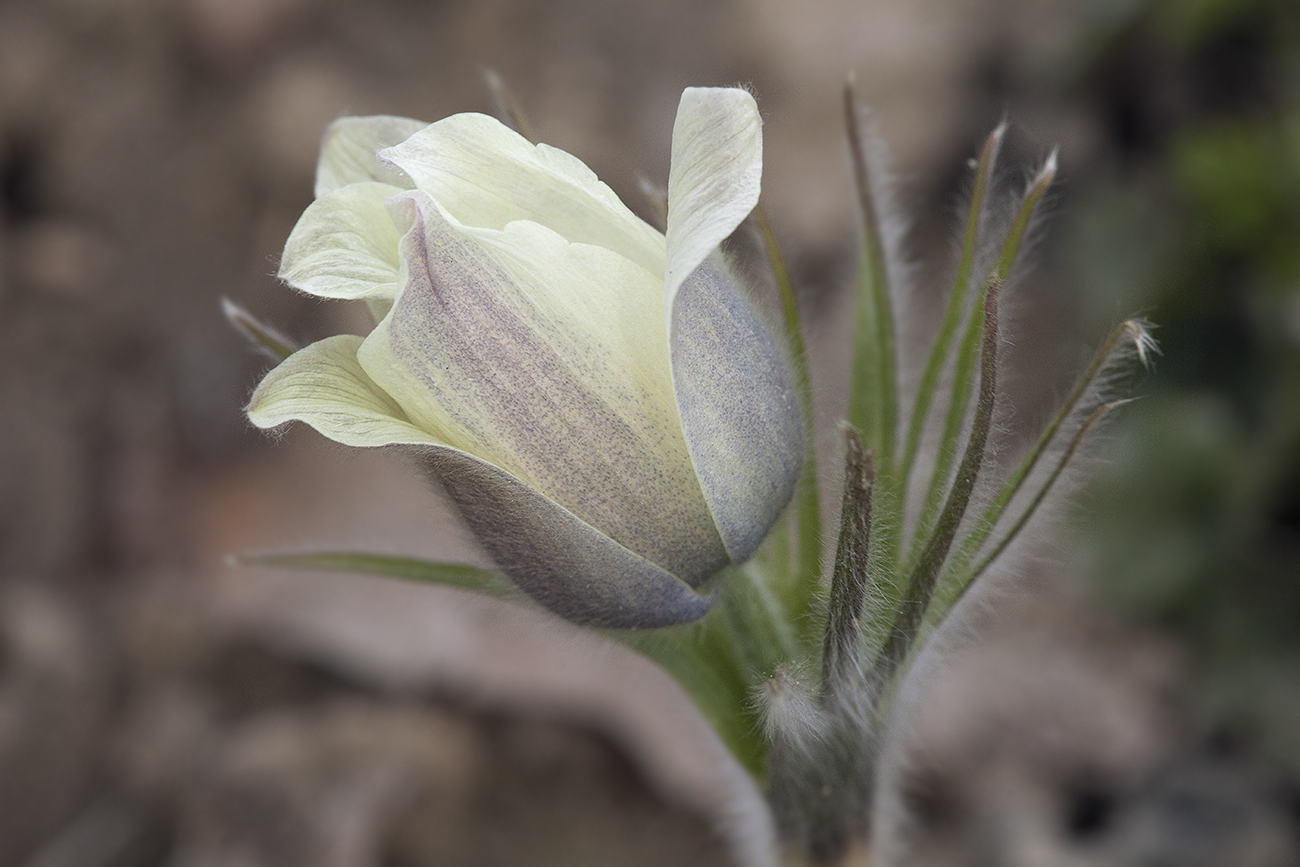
(280, 181, 402, 299)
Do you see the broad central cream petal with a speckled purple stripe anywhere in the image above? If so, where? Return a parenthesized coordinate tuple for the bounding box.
(359, 191, 727, 585)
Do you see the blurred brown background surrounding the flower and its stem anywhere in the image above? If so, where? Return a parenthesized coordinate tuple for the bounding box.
(0, 0, 1300, 867)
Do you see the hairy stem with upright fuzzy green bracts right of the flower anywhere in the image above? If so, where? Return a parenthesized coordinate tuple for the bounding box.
(761, 84, 1156, 864)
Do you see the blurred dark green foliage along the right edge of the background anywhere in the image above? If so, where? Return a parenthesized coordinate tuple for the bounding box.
(1075, 0, 1300, 770)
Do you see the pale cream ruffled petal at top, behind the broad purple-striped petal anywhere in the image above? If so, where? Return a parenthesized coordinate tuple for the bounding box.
(380, 114, 664, 277)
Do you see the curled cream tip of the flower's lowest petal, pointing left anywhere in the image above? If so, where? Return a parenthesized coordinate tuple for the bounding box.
(248, 334, 438, 446)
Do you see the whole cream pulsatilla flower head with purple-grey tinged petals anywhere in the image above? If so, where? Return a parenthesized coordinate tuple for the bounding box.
(248, 88, 803, 627)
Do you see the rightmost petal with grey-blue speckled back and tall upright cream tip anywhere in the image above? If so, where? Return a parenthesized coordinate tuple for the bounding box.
(664, 87, 803, 563)
